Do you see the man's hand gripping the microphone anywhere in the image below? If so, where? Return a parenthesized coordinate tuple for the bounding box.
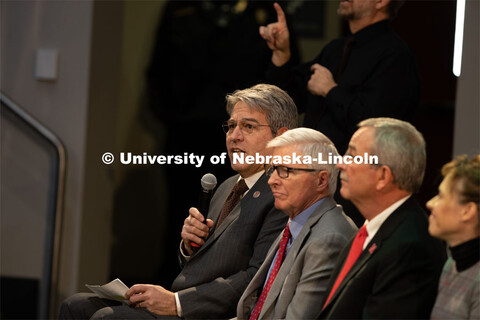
(182, 208, 213, 255)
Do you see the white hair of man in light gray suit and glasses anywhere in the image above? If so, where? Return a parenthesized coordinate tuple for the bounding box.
(267, 128, 338, 196)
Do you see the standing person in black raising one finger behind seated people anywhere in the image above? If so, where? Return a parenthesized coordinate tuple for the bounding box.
(260, 0, 420, 225)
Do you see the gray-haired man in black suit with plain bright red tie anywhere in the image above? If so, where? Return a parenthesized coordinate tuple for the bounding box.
(320, 118, 444, 319)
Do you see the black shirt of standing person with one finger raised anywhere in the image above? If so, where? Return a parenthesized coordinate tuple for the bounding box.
(267, 20, 420, 154)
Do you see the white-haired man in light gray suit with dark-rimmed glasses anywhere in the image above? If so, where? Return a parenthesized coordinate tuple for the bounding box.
(237, 128, 357, 319)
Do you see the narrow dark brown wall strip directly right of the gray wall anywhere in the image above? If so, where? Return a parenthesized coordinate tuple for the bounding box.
(77, 1, 123, 298)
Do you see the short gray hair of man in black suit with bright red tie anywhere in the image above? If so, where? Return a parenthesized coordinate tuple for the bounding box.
(358, 118, 427, 192)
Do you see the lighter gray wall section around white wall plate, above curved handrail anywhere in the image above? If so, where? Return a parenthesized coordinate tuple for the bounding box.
(1, 1, 92, 304)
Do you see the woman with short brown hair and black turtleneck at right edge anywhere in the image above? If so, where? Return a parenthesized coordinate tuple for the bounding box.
(427, 155, 480, 319)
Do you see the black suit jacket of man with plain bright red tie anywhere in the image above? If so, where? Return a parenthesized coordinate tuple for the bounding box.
(319, 197, 445, 319)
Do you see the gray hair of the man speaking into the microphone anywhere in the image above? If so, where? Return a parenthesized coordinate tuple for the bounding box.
(227, 84, 298, 135)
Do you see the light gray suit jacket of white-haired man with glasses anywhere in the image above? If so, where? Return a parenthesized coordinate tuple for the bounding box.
(237, 197, 357, 320)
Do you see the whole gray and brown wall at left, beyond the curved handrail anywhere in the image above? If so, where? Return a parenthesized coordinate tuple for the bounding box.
(1, 1, 164, 312)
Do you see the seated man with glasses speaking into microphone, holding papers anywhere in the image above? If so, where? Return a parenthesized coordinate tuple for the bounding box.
(60, 84, 297, 319)
